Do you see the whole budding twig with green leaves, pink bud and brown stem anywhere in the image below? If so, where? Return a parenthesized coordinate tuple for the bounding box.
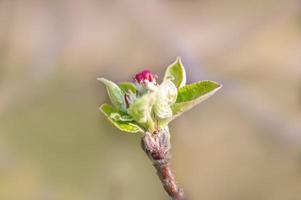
(98, 58, 221, 200)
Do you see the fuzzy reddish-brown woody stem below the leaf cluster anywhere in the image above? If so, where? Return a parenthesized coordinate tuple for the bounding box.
(141, 129, 185, 200)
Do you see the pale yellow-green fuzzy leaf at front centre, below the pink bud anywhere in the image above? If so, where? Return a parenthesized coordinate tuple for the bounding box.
(128, 92, 156, 129)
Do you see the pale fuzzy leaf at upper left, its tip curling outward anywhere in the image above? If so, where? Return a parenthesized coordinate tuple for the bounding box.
(97, 78, 126, 111)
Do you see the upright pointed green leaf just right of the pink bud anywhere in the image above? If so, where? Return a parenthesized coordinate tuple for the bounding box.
(163, 57, 186, 88)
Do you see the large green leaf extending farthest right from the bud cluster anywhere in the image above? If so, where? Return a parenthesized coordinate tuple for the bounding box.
(172, 81, 222, 118)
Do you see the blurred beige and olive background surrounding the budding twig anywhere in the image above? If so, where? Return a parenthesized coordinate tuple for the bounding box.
(0, 0, 301, 200)
